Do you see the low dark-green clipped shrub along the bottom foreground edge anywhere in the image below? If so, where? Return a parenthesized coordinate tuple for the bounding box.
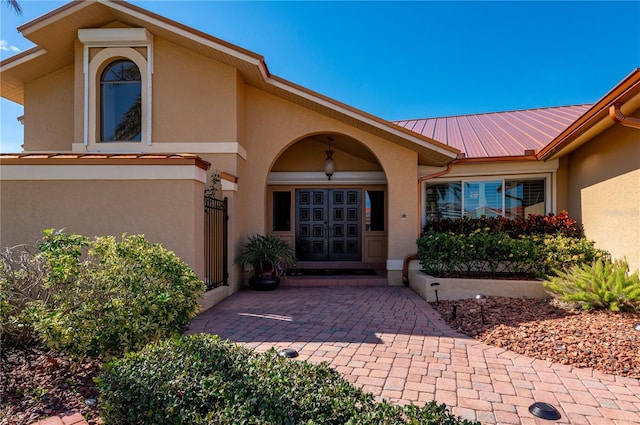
(98, 335, 480, 425)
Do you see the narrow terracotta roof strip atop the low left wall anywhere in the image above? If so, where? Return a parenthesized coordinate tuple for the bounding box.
(0, 152, 210, 170)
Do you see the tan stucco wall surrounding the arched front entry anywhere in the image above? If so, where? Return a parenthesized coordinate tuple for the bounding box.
(234, 87, 418, 278)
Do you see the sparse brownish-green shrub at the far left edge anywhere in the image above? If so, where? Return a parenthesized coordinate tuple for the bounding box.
(0, 245, 48, 347)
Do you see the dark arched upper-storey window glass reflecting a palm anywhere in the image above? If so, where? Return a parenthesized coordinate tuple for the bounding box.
(100, 59, 142, 142)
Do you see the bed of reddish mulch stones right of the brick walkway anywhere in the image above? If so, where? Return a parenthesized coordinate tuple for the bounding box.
(431, 297, 640, 379)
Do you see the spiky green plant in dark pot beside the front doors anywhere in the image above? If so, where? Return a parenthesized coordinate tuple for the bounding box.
(240, 234, 296, 291)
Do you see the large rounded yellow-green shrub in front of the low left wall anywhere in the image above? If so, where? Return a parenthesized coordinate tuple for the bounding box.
(30, 230, 204, 358)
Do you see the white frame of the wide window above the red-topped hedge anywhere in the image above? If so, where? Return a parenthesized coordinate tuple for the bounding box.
(420, 173, 555, 226)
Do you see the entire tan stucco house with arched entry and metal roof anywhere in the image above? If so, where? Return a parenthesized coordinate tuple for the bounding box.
(0, 1, 640, 305)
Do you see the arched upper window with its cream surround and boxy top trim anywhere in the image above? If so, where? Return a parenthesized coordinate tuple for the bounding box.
(78, 28, 153, 147)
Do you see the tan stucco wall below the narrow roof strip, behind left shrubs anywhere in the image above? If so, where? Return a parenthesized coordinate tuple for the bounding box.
(0, 180, 204, 278)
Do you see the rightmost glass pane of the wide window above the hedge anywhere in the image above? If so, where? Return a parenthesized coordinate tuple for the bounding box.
(505, 179, 546, 218)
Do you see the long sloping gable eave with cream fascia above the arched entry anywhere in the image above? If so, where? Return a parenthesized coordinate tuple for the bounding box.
(0, 0, 459, 166)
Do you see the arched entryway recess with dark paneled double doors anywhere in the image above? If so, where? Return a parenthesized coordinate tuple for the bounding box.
(267, 133, 387, 264)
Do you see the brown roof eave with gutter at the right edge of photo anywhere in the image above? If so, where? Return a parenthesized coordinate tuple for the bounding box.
(537, 68, 640, 160)
